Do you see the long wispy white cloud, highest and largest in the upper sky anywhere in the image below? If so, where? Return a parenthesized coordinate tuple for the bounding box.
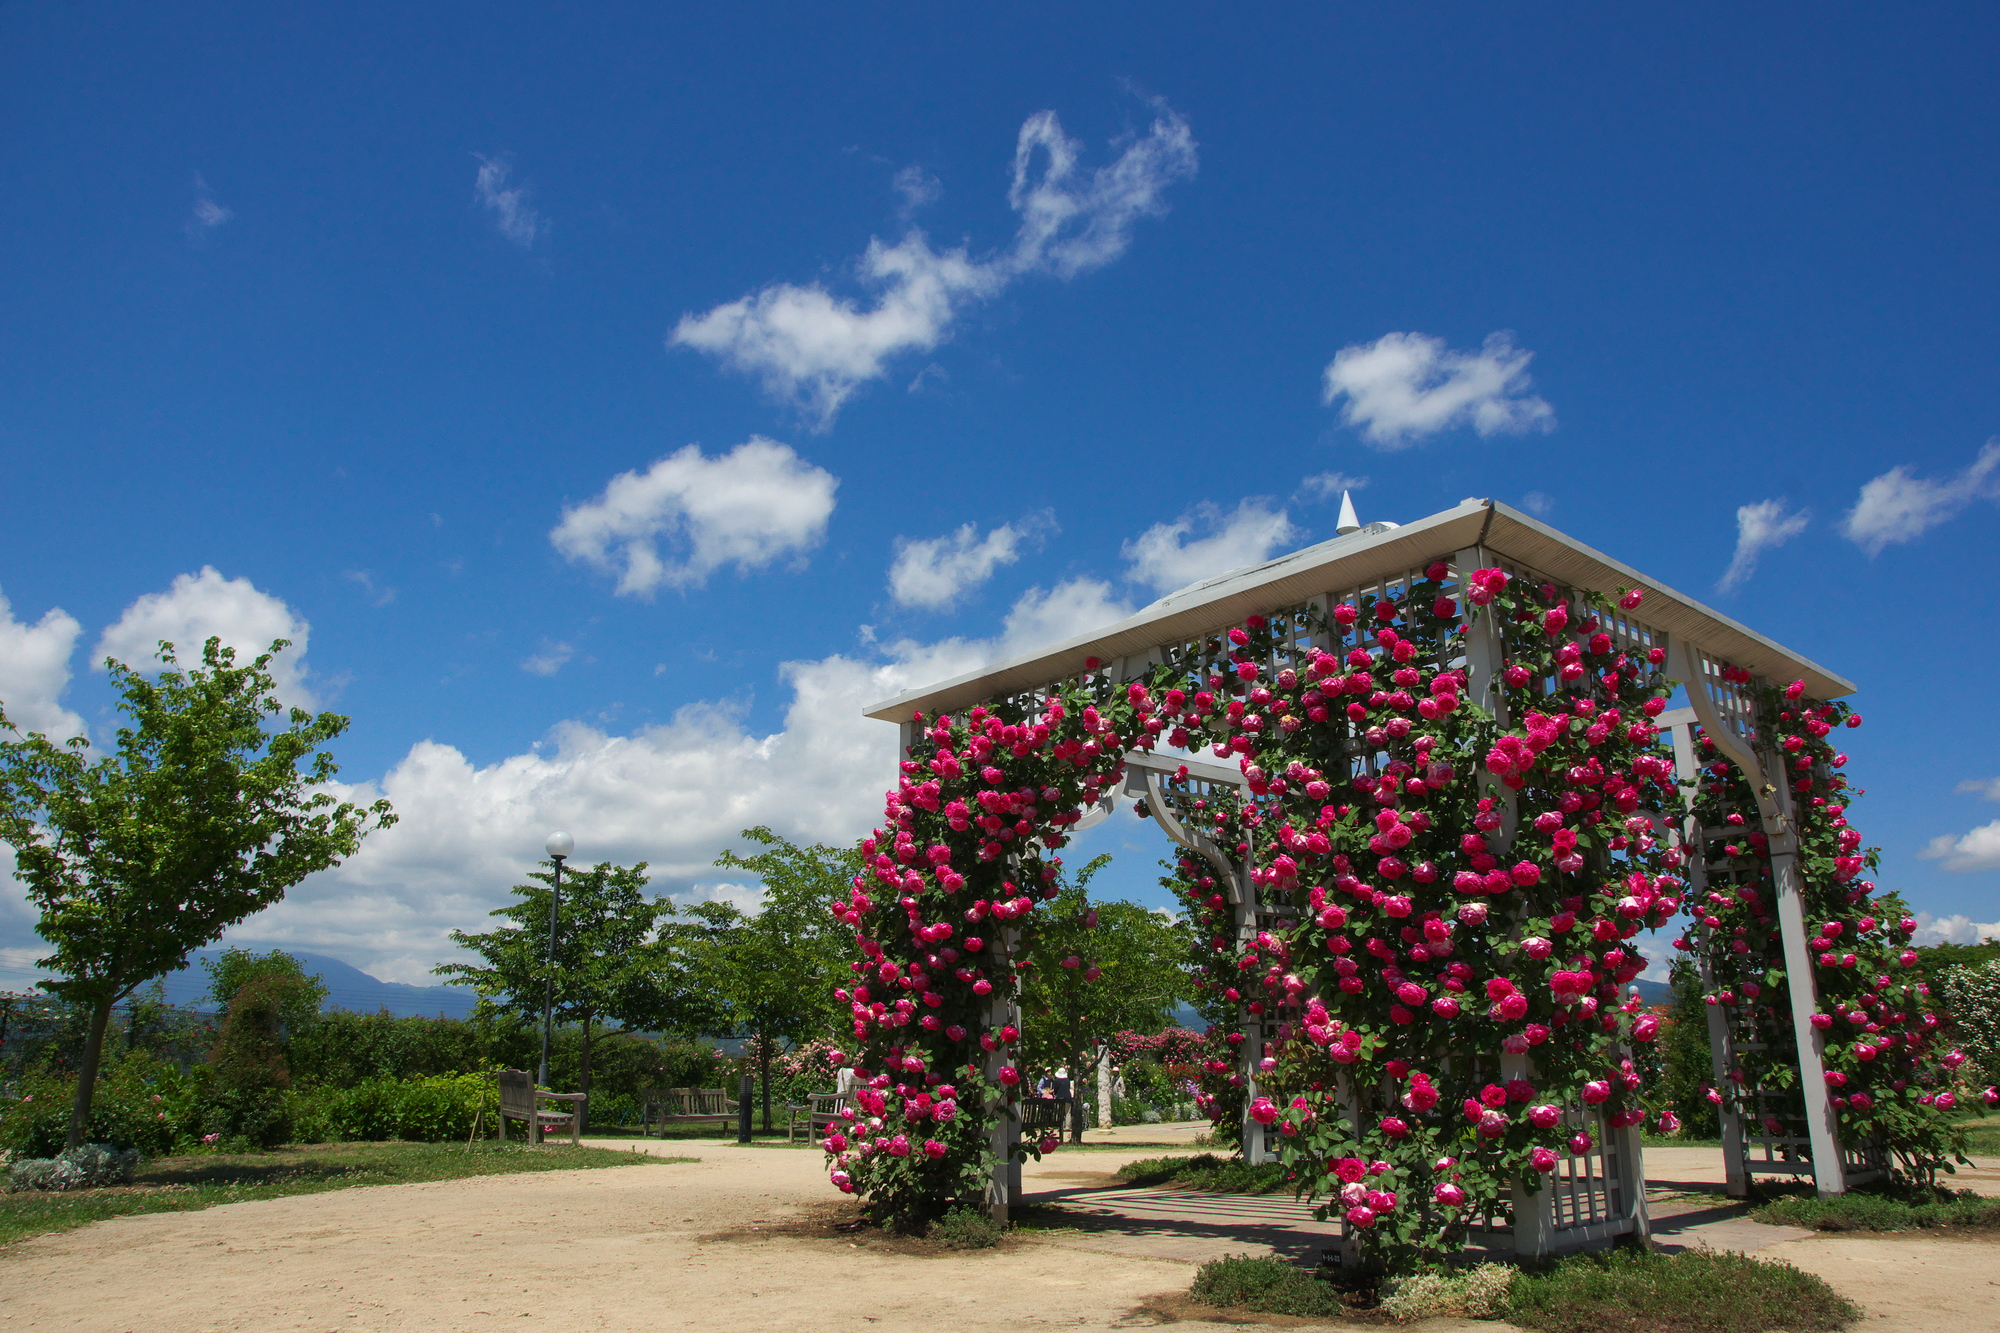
(670, 104, 1196, 430)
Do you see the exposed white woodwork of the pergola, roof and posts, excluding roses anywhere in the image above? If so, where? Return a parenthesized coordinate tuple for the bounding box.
(868, 498, 1878, 1255)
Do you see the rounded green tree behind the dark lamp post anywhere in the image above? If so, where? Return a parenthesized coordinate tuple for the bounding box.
(434, 861, 690, 1121)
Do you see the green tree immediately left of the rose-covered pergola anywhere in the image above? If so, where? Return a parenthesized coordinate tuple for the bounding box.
(688, 825, 862, 1131)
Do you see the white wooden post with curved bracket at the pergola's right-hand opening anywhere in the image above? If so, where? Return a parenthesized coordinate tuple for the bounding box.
(1670, 638, 1848, 1199)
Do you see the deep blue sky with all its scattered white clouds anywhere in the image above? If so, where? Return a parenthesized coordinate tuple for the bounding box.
(0, 0, 2000, 981)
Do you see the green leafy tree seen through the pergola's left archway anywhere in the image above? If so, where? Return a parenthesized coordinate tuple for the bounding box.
(1020, 855, 1194, 1143)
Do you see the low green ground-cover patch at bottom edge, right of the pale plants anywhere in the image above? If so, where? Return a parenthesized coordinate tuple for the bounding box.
(1506, 1249, 1860, 1333)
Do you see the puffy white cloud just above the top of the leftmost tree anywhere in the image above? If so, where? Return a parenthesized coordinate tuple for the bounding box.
(92, 564, 318, 709)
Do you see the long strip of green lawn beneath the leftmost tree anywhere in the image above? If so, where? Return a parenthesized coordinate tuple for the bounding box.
(0, 1143, 698, 1245)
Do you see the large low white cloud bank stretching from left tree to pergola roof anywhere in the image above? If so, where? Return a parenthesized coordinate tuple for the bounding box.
(230, 578, 1132, 983)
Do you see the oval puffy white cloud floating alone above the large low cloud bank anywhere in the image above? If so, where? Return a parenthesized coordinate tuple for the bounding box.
(548, 436, 840, 596)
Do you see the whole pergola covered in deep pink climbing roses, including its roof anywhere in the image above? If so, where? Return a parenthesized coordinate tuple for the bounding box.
(824, 500, 1958, 1269)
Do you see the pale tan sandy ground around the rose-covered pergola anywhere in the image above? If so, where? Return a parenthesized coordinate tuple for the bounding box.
(0, 1127, 2000, 1333)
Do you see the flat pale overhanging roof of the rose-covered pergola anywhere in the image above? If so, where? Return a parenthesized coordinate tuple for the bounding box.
(868, 500, 1854, 723)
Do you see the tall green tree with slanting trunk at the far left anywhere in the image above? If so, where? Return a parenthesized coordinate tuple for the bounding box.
(0, 638, 396, 1147)
